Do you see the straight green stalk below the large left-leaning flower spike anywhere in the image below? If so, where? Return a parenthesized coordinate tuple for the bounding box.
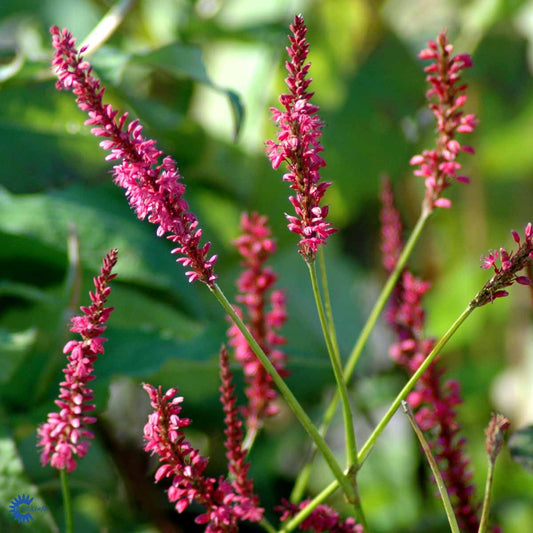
(209, 283, 357, 502)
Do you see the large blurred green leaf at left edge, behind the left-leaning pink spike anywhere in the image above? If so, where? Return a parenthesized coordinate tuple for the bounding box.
(0, 184, 195, 298)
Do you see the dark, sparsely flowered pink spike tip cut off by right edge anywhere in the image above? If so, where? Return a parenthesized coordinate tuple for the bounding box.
(470, 222, 533, 307)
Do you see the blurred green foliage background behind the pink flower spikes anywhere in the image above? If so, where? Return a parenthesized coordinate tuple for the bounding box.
(0, 0, 533, 533)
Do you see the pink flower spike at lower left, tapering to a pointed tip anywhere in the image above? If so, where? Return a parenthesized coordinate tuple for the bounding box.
(37, 250, 117, 472)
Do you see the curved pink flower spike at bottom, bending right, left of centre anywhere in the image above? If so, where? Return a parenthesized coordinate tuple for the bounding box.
(143, 381, 263, 533)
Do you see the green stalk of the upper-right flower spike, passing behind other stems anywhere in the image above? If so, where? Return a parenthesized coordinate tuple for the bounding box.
(291, 211, 431, 502)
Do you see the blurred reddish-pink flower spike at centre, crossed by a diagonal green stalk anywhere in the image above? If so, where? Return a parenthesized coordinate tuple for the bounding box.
(228, 213, 287, 430)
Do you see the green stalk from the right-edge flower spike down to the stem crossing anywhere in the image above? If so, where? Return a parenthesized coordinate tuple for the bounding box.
(358, 306, 474, 465)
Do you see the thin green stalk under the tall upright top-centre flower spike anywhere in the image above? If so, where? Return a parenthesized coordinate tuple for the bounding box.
(307, 263, 357, 468)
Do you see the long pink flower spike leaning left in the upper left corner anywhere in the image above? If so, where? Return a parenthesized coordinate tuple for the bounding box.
(50, 26, 216, 285)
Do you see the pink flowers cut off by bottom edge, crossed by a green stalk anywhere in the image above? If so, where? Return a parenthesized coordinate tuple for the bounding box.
(276, 500, 363, 533)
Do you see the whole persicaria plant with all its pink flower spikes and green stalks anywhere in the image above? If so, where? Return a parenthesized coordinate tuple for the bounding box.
(17, 10, 533, 533)
